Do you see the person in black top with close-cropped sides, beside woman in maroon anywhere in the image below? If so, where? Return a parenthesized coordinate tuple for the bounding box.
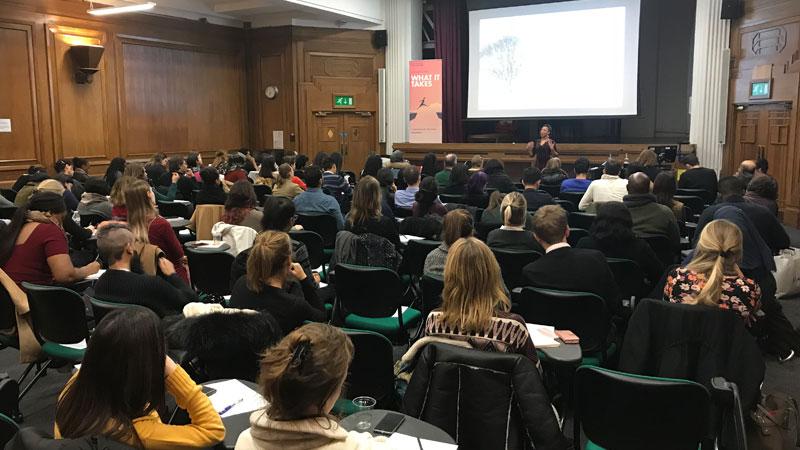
(94, 223, 198, 318)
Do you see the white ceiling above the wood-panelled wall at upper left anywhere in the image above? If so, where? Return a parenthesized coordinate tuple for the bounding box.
(86, 0, 384, 28)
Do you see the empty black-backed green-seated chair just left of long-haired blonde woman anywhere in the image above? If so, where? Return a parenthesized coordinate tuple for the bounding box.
(334, 264, 422, 341)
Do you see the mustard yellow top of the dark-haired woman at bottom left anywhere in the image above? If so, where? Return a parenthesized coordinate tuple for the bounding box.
(53, 366, 225, 450)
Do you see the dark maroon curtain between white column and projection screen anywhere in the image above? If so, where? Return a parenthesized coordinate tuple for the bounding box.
(433, 0, 467, 142)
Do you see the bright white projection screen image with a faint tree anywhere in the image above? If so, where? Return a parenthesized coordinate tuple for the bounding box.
(468, 0, 639, 118)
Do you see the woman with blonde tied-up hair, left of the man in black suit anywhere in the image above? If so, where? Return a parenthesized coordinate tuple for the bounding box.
(486, 191, 544, 253)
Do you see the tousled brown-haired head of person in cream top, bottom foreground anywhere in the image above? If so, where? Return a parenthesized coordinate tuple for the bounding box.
(258, 323, 353, 420)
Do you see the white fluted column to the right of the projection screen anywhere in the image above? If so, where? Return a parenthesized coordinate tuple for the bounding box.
(689, 0, 731, 172)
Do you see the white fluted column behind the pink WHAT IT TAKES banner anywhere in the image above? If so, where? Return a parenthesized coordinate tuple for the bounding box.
(386, 0, 422, 153)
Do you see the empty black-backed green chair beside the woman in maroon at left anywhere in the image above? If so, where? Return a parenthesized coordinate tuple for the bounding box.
(22, 283, 89, 363)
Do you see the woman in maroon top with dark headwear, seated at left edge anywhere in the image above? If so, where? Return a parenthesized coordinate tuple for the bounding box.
(0, 192, 100, 285)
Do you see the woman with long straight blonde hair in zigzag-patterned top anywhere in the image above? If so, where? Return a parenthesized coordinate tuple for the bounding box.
(424, 237, 539, 366)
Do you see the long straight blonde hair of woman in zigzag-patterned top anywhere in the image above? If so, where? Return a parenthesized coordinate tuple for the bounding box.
(442, 237, 511, 332)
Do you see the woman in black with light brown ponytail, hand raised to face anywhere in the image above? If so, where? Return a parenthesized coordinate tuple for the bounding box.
(230, 231, 327, 333)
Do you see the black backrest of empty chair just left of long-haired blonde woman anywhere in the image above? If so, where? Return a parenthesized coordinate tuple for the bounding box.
(335, 264, 404, 318)
